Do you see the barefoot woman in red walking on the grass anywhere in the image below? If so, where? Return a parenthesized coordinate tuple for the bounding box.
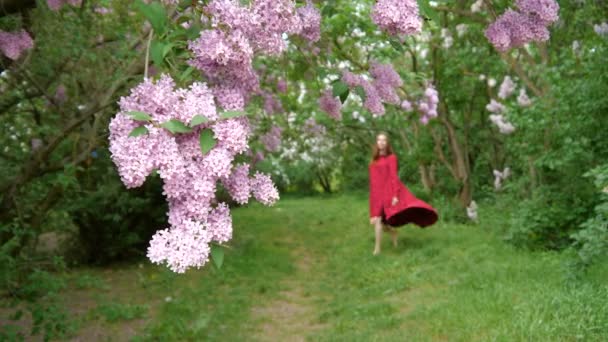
(369, 133, 437, 255)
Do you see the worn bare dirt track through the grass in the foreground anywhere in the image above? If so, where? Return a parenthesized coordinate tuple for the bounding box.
(251, 242, 324, 341)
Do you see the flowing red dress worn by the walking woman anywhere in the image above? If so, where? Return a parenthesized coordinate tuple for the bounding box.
(369, 154, 438, 228)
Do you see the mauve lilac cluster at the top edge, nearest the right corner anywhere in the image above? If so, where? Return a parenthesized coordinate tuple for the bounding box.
(485, 0, 559, 52)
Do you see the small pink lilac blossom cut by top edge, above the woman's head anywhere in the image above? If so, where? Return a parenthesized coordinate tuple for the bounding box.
(372, 0, 422, 35)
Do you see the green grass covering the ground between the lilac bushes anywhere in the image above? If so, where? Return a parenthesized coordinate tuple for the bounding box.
(2, 195, 608, 341)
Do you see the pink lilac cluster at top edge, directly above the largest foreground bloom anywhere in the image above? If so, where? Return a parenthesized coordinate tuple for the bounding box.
(188, 0, 321, 110)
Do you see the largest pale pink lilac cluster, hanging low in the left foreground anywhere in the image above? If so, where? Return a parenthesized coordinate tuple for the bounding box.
(109, 75, 278, 273)
